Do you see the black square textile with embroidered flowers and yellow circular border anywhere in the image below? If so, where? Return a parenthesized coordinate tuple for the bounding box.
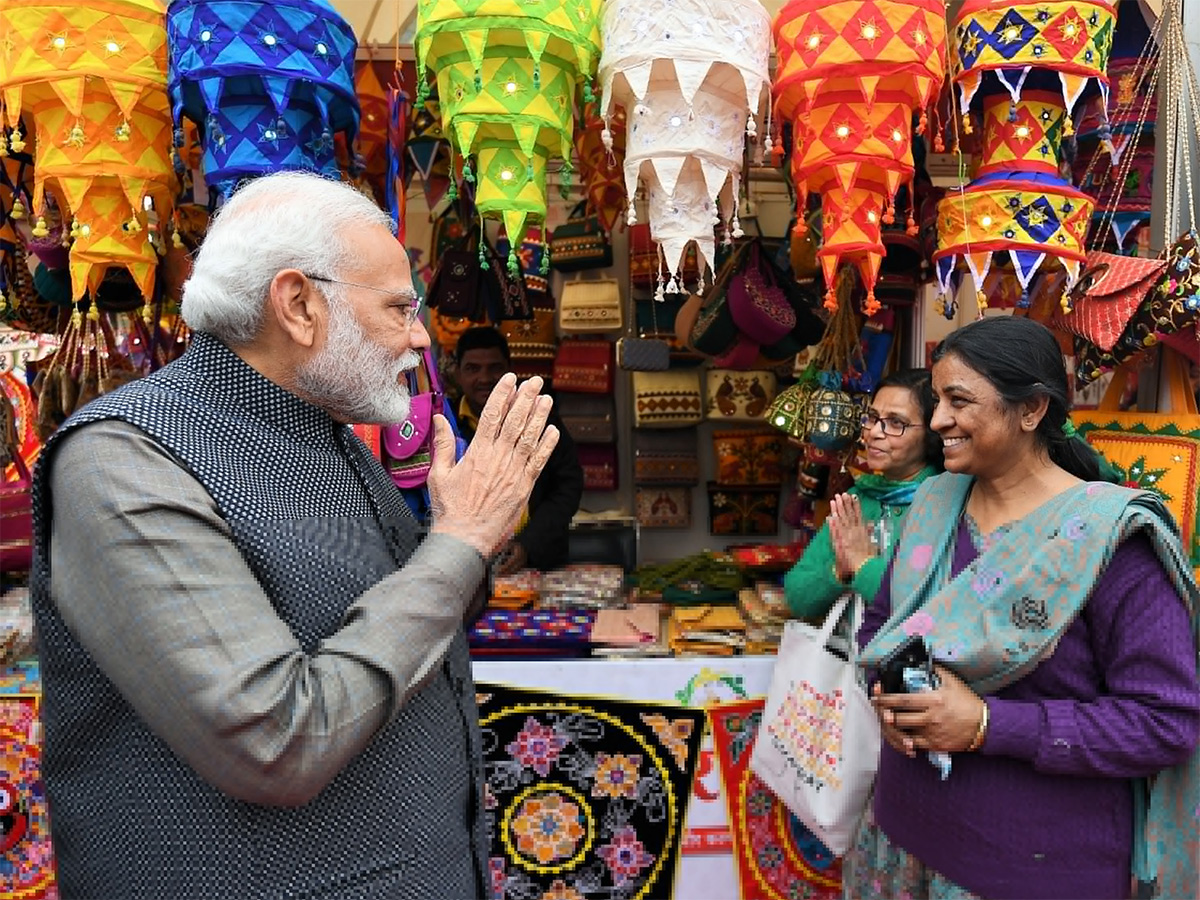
(476, 684, 704, 900)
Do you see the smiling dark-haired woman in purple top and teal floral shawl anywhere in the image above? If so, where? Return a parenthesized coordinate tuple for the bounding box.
(845, 317, 1200, 900)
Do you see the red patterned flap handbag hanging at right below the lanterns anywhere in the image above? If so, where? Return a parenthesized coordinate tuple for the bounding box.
(1049, 251, 1166, 350)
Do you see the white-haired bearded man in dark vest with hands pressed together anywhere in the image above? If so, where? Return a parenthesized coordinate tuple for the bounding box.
(32, 173, 558, 900)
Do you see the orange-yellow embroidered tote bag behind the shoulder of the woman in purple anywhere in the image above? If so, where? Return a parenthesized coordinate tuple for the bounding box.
(1070, 350, 1200, 566)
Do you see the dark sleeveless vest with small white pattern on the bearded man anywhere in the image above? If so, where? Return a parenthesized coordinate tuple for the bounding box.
(32, 335, 487, 900)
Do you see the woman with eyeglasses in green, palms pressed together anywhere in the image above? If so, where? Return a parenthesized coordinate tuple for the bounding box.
(784, 368, 942, 620)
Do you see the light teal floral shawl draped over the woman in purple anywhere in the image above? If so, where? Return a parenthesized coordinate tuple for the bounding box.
(859, 474, 1200, 898)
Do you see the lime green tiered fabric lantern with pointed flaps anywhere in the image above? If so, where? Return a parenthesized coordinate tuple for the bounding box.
(415, 0, 600, 274)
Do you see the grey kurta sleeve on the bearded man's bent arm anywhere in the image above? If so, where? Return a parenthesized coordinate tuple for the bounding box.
(50, 421, 484, 805)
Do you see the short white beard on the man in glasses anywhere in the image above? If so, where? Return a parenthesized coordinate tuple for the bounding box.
(296, 302, 421, 425)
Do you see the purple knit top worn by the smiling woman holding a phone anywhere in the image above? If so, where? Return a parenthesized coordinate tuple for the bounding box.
(858, 521, 1200, 900)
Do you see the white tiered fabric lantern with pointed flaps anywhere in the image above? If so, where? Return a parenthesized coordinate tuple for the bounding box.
(600, 0, 770, 293)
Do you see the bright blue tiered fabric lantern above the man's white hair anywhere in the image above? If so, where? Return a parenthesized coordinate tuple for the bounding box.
(167, 0, 359, 199)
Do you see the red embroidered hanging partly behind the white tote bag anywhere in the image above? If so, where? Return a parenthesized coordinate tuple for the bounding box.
(708, 697, 841, 900)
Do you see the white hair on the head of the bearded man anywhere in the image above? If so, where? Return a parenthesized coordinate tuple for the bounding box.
(182, 172, 395, 346)
